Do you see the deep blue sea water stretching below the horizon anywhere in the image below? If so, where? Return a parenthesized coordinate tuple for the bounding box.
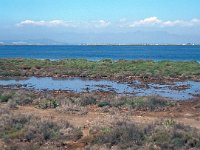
(0, 45, 200, 62)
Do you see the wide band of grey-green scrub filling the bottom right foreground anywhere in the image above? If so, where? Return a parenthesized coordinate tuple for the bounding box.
(90, 120, 200, 150)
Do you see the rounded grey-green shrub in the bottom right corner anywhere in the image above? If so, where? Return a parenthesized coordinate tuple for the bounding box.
(146, 120, 200, 149)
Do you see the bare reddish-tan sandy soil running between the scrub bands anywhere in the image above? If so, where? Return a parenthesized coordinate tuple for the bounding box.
(5, 99, 200, 134)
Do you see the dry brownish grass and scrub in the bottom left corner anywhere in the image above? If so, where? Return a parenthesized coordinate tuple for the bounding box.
(0, 108, 82, 149)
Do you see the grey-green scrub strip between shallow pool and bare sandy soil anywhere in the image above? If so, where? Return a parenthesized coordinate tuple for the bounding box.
(0, 89, 176, 111)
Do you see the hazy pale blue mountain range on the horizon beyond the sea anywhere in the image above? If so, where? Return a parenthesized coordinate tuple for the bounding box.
(0, 31, 200, 45)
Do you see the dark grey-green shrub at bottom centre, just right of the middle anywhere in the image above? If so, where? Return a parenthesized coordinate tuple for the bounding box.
(92, 122, 144, 149)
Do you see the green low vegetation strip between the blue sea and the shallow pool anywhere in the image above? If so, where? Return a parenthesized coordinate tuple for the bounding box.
(0, 59, 200, 80)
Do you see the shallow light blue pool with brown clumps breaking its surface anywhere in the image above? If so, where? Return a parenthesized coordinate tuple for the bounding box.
(0, 77, 200, 100)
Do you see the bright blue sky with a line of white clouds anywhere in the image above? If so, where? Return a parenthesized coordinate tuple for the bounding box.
(0, 0, 200, 44)
